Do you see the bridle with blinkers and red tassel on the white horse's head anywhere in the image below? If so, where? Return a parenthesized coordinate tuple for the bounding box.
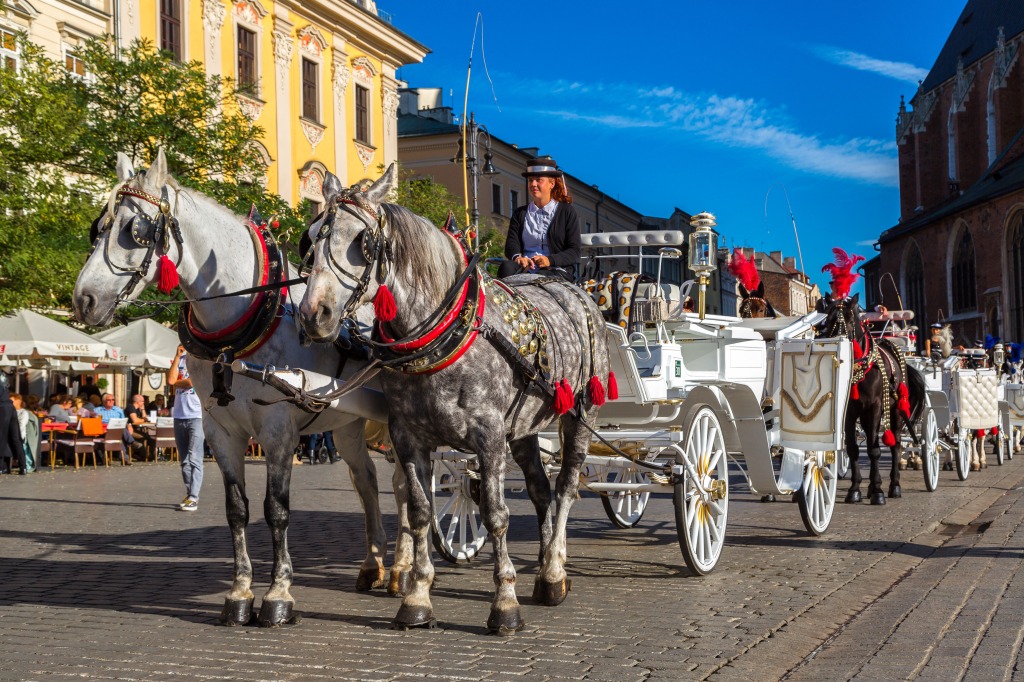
(90, 171, 184, 303)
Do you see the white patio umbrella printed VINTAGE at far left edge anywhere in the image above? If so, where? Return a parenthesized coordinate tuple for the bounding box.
(0, 310, 120, 365)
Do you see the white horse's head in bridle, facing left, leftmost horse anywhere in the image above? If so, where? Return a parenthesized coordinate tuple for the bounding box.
(72, 148, 181, 327)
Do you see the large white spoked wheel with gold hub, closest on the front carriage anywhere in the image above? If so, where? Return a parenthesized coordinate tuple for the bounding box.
(673, 406, 729, 576)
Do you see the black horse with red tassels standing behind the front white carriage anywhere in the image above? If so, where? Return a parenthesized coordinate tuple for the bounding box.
(817, 294, 925, 505)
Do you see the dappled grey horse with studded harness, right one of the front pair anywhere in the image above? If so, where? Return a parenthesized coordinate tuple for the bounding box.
(300, 165, 608, 634)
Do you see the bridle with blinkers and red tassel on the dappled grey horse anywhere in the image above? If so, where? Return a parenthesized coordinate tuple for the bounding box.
(302, 191, 394, 321)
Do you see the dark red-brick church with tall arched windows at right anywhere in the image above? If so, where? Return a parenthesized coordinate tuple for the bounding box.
(863, 0, 1024, 345)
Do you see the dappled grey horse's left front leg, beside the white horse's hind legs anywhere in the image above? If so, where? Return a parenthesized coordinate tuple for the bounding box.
(390, 430, 434, 630)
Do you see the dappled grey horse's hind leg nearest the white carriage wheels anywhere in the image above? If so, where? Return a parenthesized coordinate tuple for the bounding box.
(534, 417, 590, 606)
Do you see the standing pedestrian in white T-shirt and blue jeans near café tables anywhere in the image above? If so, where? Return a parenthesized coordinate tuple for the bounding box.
(167, 346, 204, 511)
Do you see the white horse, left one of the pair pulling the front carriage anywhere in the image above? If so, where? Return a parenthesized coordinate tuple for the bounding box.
(74, 150, 412, 626)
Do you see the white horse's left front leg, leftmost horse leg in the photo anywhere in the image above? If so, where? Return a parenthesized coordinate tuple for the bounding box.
(205, 428, 254, 626)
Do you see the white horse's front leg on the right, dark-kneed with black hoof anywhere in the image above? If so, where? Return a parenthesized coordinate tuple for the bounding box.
(257, 425, 298, 628)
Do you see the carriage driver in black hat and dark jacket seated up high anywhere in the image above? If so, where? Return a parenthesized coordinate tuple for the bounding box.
(498, 157, 580, 282)
